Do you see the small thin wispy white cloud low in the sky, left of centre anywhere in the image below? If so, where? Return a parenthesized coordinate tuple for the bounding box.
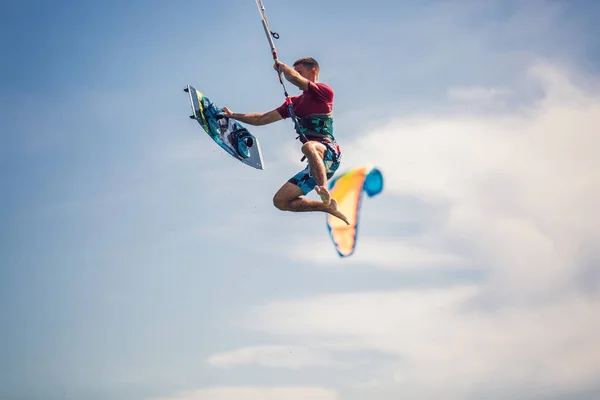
(208, 346, 334, 369)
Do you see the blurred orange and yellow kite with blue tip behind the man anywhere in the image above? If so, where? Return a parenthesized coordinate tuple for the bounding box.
(327, 165, 383, 257)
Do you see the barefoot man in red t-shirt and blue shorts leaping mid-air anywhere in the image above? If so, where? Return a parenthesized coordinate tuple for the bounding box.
(223, 57, 348, 224)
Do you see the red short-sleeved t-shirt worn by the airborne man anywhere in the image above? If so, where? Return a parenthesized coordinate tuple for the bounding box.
(276, 81, 333, 119)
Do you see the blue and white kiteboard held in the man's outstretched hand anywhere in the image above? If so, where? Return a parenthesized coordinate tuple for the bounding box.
(183, 85, 264, 169)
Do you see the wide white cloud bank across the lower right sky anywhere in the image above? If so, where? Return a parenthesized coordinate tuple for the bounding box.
(252, 287, 600, 399)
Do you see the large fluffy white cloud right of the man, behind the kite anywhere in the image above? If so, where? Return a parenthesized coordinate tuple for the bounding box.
(346, 61, 600, 296)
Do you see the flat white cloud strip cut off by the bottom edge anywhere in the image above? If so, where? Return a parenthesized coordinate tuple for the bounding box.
(152, 386, 339, 400)
